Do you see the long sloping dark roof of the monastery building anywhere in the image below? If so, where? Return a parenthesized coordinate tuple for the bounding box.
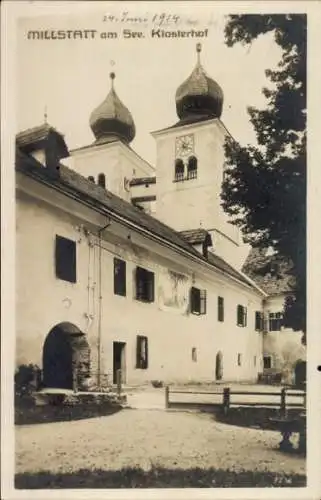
(16, 146, 257, 290)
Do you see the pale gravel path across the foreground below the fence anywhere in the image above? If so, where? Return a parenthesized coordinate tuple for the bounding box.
(16, 409, 305, 474)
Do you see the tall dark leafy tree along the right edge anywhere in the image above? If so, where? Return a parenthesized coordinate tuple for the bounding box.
(221, 14, 307, 332)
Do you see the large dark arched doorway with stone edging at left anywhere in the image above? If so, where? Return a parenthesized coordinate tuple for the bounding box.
(43, 323, 90, 389)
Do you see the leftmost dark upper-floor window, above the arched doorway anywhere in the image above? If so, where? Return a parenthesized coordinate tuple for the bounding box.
(55, 235, 77, 283)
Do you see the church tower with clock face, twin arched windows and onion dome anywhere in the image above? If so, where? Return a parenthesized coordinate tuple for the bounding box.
(152, 44, 243, 267)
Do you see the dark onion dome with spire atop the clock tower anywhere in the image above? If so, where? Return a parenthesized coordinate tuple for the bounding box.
(176, 43, 223, 120)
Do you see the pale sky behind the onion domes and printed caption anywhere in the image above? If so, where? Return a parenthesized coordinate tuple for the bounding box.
(16, 2, 281, 164)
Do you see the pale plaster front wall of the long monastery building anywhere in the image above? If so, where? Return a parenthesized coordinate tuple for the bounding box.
(16, 173, 263, 384)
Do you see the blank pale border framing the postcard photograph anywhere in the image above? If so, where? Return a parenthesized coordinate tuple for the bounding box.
(1, 0, 321, 500)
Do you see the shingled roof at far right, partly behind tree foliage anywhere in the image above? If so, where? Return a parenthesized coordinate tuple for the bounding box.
(242, 248, 296, 295)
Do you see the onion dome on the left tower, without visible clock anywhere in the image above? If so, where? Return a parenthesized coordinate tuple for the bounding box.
(89, 73, 136, 143)
